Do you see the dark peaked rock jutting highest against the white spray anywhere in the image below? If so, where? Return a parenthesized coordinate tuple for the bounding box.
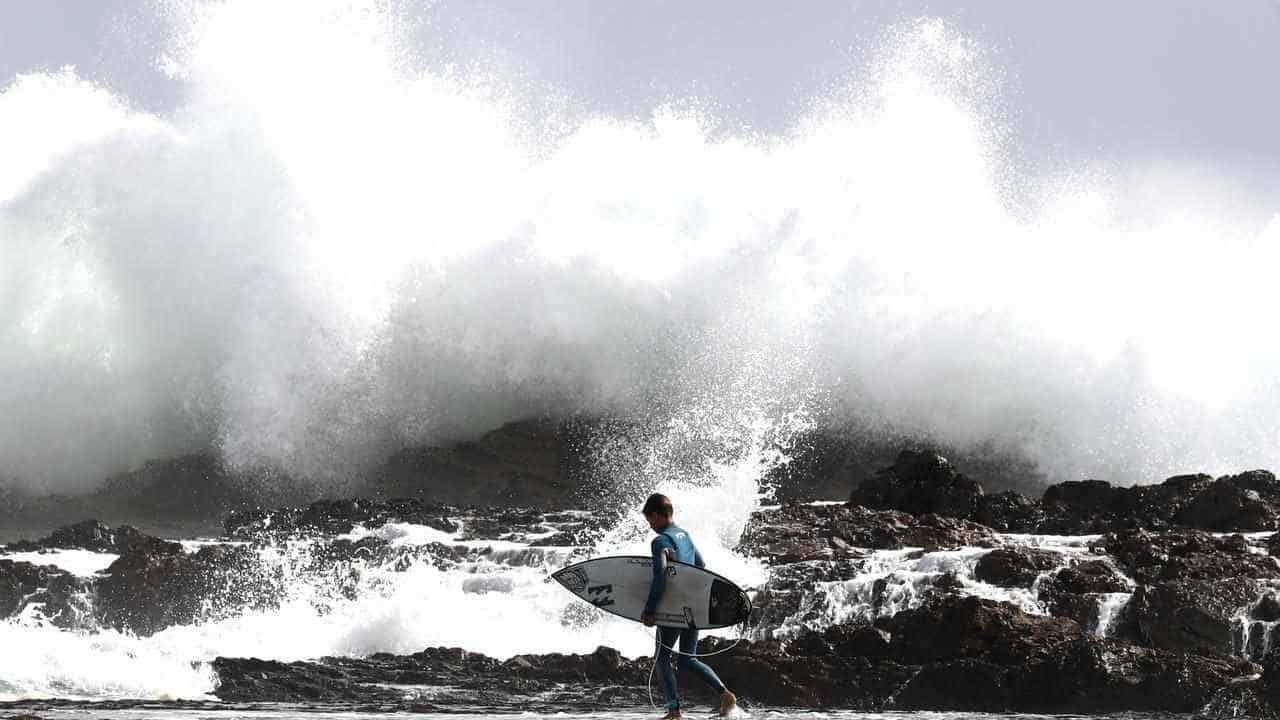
(849, 450, 983, 519)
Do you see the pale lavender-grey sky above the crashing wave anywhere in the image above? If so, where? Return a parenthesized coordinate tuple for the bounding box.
(0, 0, 1280, 170)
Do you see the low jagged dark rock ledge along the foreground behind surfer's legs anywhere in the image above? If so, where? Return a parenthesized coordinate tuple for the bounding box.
(204, 597, 1274, 714)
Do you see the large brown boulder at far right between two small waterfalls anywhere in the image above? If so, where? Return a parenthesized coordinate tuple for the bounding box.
(1130, 578, 1258, 655)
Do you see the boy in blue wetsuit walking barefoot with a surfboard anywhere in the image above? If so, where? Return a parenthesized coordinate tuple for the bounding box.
(640, 495, 737, 720)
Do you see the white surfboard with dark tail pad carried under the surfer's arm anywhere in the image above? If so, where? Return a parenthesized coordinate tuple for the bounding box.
(552, 555, 751, 629)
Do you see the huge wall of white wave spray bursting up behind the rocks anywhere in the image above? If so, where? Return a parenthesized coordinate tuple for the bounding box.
(0, 1, 1280, 489)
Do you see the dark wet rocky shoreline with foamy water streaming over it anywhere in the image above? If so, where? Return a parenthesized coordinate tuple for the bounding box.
(0, 452, 1280, 717)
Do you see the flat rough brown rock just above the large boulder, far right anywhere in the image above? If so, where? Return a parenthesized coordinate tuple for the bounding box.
(1094, 530, 1280, 584)
